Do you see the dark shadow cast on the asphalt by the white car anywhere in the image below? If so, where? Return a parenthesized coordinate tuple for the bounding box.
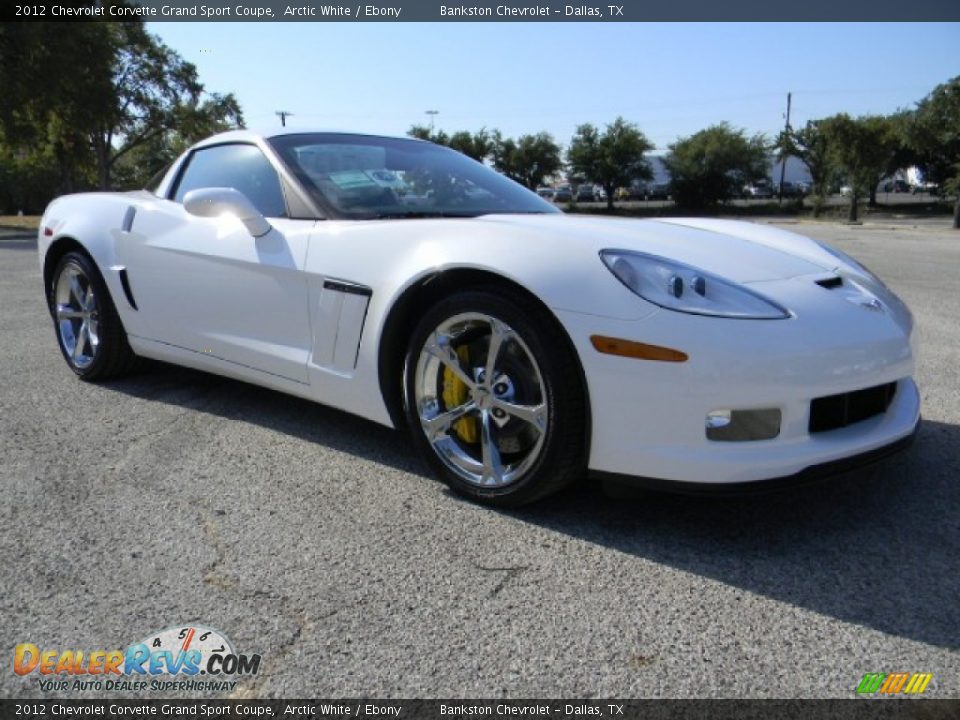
(104, 362, 960, 649)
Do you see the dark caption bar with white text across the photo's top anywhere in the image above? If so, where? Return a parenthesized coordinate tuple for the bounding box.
(0, 0, 960, 22)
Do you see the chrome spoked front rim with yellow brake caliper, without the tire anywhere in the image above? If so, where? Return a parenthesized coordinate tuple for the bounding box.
(413, 312, 549, 489)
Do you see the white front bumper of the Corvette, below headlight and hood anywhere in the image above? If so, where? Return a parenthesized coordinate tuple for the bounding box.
(557, 292, 920, 485)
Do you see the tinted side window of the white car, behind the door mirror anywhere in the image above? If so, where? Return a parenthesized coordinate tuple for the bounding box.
(173, 145, 287, 217)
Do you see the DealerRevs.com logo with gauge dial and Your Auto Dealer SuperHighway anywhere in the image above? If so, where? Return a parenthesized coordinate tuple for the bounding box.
(13, 625, 260, 692)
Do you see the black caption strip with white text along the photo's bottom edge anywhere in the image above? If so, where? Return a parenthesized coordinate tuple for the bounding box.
(0, 699, 960, 720)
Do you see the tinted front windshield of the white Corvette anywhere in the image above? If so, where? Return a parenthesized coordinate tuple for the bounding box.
(270, 133, 559, 219)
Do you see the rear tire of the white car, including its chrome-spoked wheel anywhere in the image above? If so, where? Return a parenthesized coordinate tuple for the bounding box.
(47, 252, 137, 381)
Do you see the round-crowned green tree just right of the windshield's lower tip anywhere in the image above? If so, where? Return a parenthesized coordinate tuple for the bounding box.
(567, 117, 653, 210)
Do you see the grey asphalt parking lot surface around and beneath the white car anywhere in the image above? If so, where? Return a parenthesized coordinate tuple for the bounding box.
(0, 219, 960, 698)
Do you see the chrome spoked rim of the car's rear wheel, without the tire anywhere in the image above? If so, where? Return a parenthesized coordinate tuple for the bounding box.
(53, 262, 100, 370)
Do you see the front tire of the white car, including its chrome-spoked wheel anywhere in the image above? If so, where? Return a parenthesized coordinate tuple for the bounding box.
(403, 286, 588, 507)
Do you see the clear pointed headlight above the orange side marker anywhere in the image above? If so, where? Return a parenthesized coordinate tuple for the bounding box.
(600, 250, 790, 320)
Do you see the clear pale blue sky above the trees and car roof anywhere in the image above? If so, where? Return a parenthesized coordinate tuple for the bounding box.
(148, 22, 960, 150)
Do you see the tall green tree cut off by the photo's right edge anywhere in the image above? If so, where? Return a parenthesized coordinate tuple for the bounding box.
(907, 76, 960, 229)
